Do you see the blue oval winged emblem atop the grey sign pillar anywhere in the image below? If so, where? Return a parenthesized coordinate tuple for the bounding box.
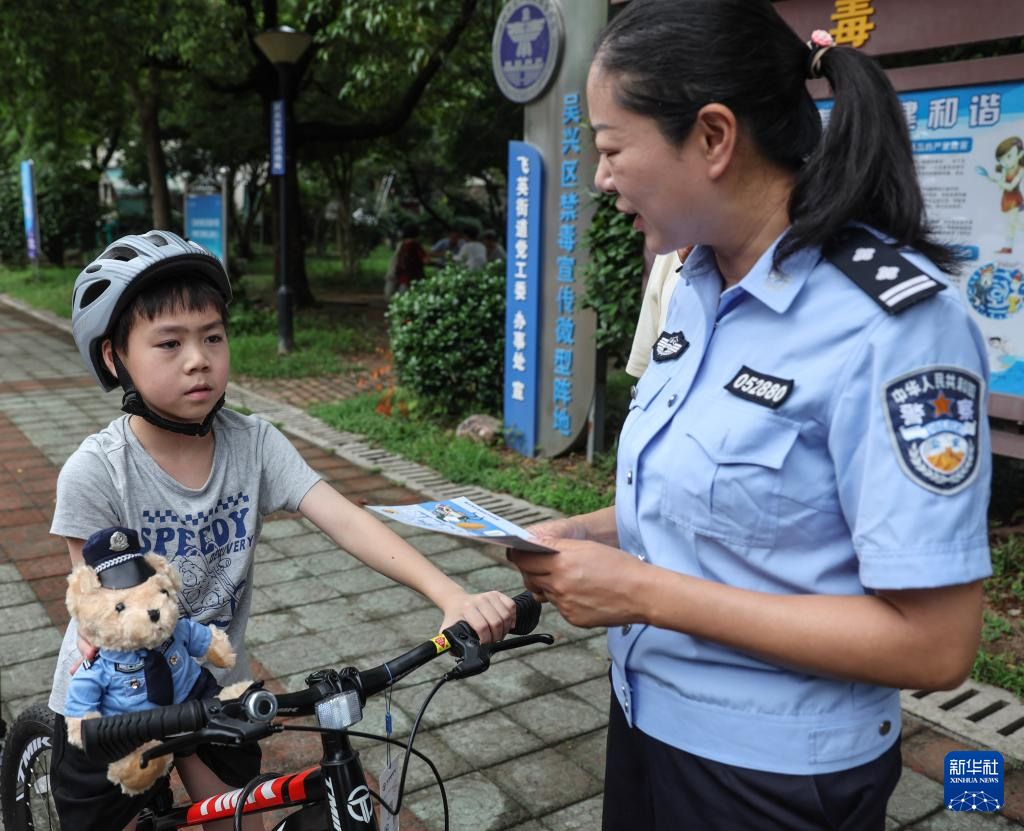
(492, 0, 562, 103)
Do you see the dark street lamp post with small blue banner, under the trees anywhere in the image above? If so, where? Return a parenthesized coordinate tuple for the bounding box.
(256, 26, 312, 355)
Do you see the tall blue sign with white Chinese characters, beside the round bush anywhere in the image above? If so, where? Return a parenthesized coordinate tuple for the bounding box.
(505, 141, 544, 456)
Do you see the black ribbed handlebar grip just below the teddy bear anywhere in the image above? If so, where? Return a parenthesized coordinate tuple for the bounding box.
(82, 701, 210, 762)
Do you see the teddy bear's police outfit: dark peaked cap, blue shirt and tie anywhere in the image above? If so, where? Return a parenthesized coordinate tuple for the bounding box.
(66, 528, 226, 717)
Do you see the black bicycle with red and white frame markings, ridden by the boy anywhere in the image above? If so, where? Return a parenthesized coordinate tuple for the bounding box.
(0, 593, 554, 831)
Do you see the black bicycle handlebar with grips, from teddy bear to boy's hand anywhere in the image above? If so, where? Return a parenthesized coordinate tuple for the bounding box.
(82, 592, 541, 762)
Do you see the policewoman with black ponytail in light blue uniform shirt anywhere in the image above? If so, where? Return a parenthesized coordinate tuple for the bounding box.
(510, 0, 990, 831)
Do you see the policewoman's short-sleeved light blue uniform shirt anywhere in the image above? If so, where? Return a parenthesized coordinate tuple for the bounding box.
(608, 227, 991, 774)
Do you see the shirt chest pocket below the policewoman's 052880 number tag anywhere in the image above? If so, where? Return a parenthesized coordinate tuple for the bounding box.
(662, 399, 800, 548)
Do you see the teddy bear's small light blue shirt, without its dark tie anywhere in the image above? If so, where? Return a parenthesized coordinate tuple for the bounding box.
(65, 618, 213, 718)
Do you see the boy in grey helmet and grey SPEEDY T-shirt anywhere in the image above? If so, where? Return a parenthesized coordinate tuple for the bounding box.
(50, 231, 514, 831)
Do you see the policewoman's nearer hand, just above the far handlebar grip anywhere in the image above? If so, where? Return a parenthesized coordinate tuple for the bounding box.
(508, 537, 651, 626)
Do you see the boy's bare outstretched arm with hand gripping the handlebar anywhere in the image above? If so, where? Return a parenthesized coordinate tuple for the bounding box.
(299, 481, 515, 643)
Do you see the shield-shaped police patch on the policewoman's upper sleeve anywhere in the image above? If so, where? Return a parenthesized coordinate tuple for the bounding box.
(883, 366, 982, 495)
